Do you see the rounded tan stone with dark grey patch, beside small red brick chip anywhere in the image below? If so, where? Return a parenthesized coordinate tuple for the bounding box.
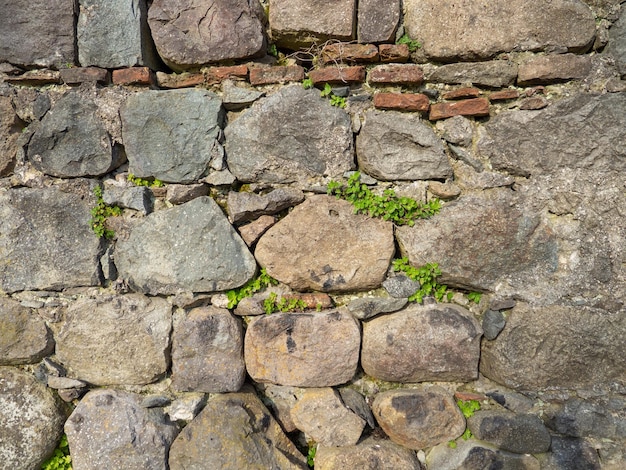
(372, 386, 465, 450)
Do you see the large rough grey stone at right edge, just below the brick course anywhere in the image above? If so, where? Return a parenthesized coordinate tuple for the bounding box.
(478, 93, 626, 176)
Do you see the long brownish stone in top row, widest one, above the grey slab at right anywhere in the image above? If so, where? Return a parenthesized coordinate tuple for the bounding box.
(404, 0, 595, 62)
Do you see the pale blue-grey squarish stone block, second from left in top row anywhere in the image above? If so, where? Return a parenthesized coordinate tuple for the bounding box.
(76, 0, 159, 69)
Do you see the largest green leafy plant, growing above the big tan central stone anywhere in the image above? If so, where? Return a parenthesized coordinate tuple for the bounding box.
(327, 171, 441, 226)
